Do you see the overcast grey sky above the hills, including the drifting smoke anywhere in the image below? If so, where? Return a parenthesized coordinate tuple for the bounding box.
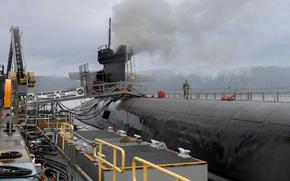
(0, 0, 290, 76)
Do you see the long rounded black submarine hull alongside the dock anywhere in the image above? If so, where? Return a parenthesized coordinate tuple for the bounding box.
(78, 98, 290, 181)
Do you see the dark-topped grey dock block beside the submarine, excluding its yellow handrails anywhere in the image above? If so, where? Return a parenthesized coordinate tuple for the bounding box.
(58, 126, 207, 181)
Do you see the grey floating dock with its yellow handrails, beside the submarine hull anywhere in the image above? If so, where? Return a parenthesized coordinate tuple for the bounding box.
(58, 121, 208, 181)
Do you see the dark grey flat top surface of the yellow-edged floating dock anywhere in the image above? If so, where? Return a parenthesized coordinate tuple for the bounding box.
(77, 130, 205, 167)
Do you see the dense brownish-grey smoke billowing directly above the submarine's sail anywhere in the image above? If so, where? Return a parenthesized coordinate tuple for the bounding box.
(113, 0, 176, 55)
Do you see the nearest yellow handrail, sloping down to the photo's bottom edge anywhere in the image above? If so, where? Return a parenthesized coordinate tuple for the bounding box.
(132, 157, 190, 181)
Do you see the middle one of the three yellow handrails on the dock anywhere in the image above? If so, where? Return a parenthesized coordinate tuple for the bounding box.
(93, 139, 125, 181)
